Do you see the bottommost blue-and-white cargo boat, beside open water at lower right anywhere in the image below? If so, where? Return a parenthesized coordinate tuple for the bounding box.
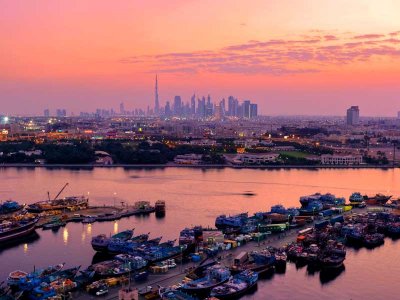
(210, 270, 258, 300)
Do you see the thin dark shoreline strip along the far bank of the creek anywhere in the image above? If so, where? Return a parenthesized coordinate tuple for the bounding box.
(0, 164, 400, 170)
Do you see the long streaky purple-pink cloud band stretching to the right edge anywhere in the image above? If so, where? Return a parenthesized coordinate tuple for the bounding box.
(120, 32, 400, 76)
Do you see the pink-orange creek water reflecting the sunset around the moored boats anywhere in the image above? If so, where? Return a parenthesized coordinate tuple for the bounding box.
(0, 168, 400, 299)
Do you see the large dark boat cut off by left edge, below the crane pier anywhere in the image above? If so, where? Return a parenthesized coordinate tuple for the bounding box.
(0, 218, 39, 243)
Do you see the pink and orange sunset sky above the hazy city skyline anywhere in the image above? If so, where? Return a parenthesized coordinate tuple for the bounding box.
(0, 0, 400, 116)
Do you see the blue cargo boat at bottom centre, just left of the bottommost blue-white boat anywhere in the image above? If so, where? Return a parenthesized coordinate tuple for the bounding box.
(181, 265, 231, 295)
